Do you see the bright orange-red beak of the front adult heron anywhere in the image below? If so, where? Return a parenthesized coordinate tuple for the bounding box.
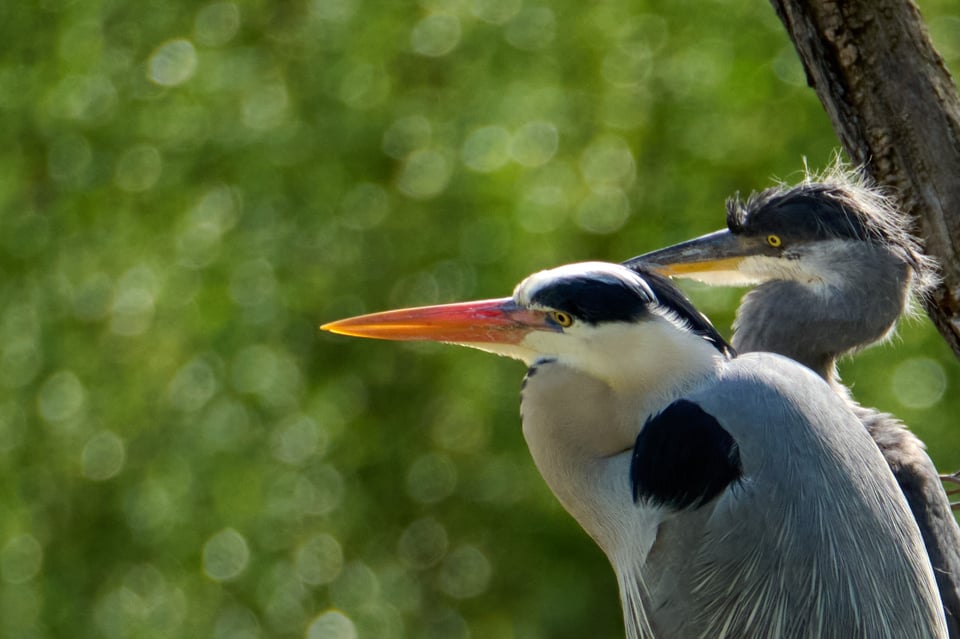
(320, 297, 552, 344)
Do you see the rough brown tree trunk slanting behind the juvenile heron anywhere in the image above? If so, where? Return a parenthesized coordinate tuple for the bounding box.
(771, 0, 960, 356)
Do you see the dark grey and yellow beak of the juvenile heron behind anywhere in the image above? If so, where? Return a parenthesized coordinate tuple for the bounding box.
(624, 230, 756, 277)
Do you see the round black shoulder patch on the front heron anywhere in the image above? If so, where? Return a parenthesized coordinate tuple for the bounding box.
(630, 399, 743, 510)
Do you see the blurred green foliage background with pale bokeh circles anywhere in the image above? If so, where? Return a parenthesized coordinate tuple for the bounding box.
(0, 0, 960, 639)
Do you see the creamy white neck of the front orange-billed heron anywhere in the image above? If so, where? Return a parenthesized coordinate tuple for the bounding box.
(521, 318, 723, 557)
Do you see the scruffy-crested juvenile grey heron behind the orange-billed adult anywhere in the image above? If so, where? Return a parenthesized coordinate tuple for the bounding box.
(627, 168, 960, 638)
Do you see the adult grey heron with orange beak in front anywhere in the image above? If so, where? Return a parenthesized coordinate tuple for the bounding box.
(321, 262, 946, 639)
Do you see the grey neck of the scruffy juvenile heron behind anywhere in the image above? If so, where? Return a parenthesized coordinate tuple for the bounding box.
(732, 243, 912, 383)
